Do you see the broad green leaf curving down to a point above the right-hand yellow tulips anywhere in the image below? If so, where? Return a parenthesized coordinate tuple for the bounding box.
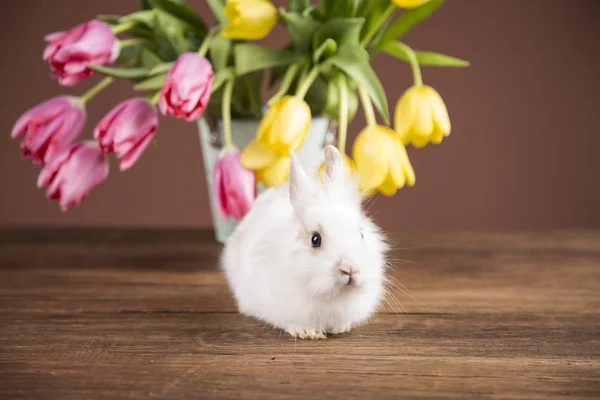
(327, 46, 390, 124)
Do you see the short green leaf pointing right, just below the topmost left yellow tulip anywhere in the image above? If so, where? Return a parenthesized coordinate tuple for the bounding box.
(234, 43, 302, 76)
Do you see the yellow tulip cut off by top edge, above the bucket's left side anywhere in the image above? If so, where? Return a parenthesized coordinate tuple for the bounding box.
(221, 0, 277, 40)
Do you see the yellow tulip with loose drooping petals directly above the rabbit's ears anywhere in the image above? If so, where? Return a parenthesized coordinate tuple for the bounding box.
(241, 96, 311, 187)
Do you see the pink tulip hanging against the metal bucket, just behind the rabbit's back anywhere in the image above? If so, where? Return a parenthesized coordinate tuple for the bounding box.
(213, 148, 256, 221)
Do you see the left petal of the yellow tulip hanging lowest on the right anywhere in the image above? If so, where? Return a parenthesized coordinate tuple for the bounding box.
(352, 126, 388, 191)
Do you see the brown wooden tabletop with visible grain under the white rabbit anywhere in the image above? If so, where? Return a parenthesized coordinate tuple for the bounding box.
(0, 229, 600, 400)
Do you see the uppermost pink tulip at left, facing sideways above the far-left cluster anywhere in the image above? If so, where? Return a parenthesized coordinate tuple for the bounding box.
(43, 19, 120, 86)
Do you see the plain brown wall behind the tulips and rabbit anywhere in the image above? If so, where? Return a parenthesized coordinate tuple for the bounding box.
(0, 0, 600, 229)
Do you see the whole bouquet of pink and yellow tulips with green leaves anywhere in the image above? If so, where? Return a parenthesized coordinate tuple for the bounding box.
(12, 0, 468, 220)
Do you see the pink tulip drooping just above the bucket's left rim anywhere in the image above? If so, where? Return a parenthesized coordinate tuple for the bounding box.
(158, 53, 215, 121)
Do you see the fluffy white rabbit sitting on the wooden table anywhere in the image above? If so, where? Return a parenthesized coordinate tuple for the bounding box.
(221, 146, 388, 339)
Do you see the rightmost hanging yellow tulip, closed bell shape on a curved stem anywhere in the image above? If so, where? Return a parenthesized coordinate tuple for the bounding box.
(394, 85, 450, 147)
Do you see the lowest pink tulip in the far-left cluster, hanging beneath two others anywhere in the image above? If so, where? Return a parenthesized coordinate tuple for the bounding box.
(38, 142, 109, 211)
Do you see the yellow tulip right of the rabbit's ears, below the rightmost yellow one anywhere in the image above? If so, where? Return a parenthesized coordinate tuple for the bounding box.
(352, 125, 415, 196)
